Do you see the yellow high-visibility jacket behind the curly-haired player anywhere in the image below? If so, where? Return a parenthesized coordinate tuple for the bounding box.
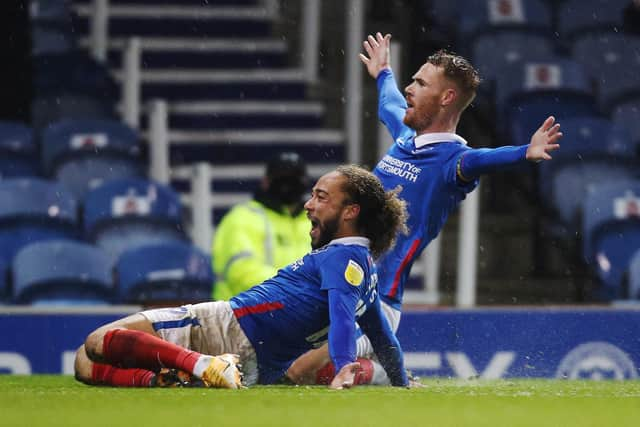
(212, 200, 311, 300)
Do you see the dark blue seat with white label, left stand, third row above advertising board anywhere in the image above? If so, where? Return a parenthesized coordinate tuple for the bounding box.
(42, 119, 144, 200)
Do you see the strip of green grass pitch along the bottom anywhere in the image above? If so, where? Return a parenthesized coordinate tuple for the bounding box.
(0, 375, 640, 427)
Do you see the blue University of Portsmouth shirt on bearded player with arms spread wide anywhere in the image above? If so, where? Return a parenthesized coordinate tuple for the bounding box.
(373, 70, 478, 310)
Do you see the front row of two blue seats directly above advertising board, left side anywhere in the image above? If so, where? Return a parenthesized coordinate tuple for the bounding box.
(0, 239, 214, 306)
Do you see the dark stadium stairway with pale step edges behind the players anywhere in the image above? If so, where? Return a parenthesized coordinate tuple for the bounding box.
(73, 0, 344, 222)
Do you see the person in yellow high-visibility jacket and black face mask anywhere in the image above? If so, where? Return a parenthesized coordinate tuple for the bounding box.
(212, 152, 311, 300)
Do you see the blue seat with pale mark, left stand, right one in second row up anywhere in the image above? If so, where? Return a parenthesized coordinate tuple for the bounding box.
(83, 178, 186, 263)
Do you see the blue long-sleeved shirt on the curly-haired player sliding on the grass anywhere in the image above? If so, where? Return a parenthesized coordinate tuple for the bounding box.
(230, 237, 406, 384)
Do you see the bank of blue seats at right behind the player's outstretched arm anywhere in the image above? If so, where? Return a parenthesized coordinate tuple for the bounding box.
(423, 0, 640, 300)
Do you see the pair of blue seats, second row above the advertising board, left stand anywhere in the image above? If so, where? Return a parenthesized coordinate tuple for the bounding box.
(0, 178, 187, 264)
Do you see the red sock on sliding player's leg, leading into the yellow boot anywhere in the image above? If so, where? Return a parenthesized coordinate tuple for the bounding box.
(102, 329, 200, 373)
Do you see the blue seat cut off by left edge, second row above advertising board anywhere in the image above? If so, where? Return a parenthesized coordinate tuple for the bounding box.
(0, 178, 78, 262)
